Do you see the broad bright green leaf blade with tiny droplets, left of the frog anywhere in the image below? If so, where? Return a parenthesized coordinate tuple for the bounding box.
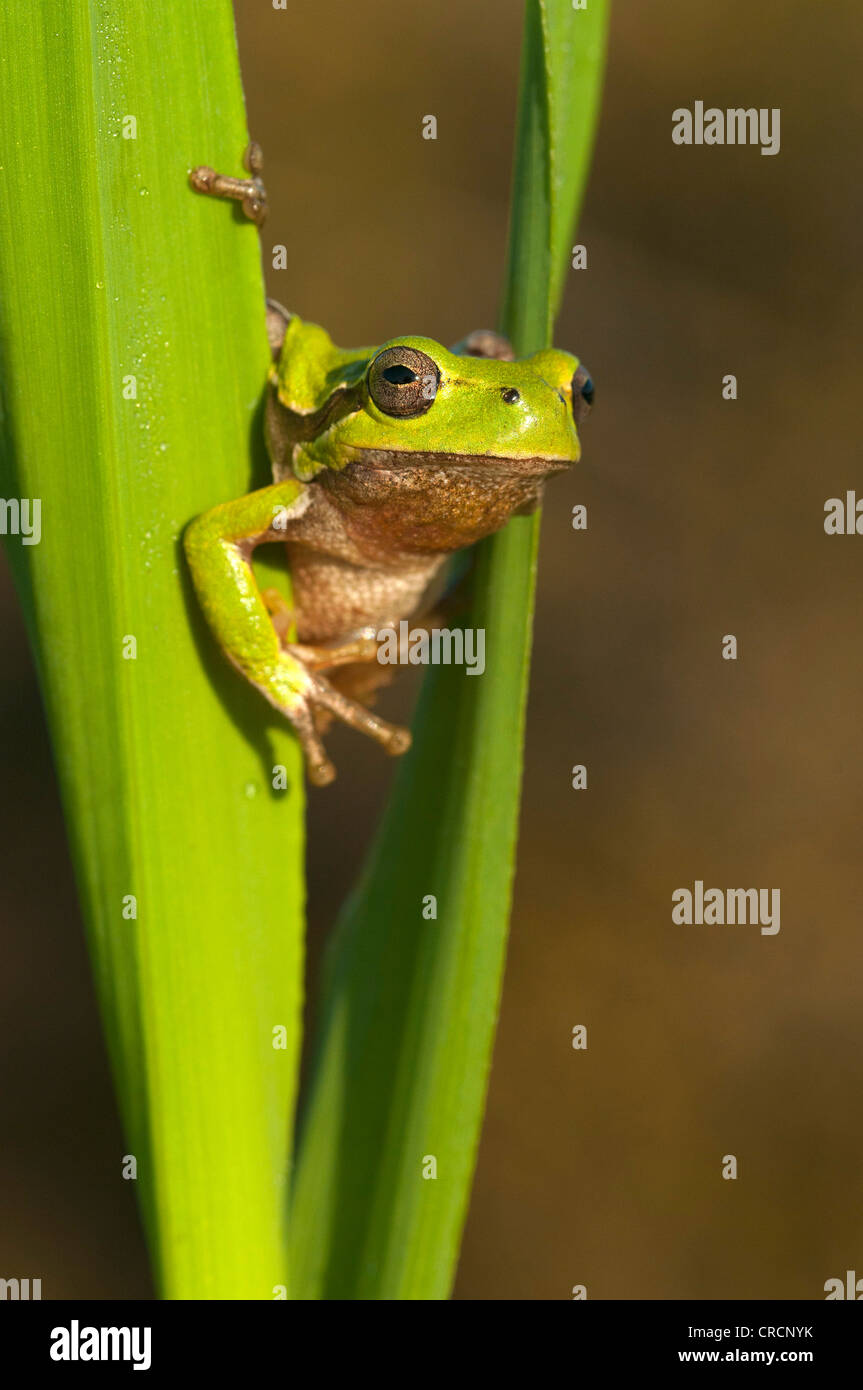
(0, 0, 303, 1298)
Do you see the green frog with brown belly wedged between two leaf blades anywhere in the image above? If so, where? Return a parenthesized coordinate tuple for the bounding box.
(183, 145, 593, 787)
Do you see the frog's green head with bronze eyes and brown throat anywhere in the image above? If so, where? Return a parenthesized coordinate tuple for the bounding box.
(270, 318, 593, 549)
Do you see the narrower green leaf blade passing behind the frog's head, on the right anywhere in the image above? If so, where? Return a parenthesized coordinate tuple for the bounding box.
(292, 0, 606, 1298)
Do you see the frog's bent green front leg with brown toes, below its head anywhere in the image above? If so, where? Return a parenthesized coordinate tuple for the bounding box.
(185, 480, 410, 787)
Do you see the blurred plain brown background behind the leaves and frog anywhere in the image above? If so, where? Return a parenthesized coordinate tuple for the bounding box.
(0, 0, 863, 1300)
